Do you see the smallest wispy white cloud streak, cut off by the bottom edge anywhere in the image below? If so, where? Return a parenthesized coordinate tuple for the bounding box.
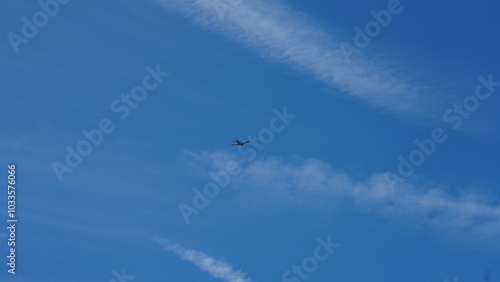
(153, 237, 252, 282)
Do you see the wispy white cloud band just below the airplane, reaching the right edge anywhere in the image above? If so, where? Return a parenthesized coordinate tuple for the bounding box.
(186, 151, 500, 246)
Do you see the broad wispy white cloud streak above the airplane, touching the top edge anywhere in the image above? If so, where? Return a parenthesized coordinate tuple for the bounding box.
(153, 0, 446, 118)
